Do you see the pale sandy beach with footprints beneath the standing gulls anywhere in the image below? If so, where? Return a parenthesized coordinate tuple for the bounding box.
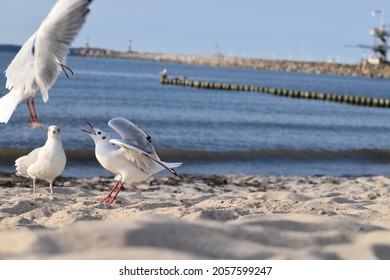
(0, 171, 390, 259)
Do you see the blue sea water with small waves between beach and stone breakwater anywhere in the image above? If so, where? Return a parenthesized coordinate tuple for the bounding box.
(0, 49, 390, 177)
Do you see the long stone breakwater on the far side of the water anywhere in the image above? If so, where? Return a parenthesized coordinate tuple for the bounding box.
(71, 49, 390, 78)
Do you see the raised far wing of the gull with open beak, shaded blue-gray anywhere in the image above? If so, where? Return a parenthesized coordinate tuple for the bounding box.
(108, 117, 156, 155)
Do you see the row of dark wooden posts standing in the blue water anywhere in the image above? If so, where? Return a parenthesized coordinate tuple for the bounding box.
(160, 76, 390, 108)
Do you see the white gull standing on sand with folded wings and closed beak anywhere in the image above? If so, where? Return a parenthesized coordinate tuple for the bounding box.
(15, 125, 66, 194)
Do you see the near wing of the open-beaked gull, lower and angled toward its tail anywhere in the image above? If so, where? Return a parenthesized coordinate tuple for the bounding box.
(110, 139, 178, 176)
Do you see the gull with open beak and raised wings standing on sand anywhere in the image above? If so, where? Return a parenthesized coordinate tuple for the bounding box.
(82, 117, 182, 204)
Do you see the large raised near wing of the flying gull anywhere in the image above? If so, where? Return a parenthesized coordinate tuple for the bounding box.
(32, 0, 91, 102)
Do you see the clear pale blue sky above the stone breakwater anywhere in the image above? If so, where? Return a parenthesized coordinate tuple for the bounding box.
(0, 0, 390, 63)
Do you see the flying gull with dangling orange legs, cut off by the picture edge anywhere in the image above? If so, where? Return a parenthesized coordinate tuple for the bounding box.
(0, 0, 92, 124)
